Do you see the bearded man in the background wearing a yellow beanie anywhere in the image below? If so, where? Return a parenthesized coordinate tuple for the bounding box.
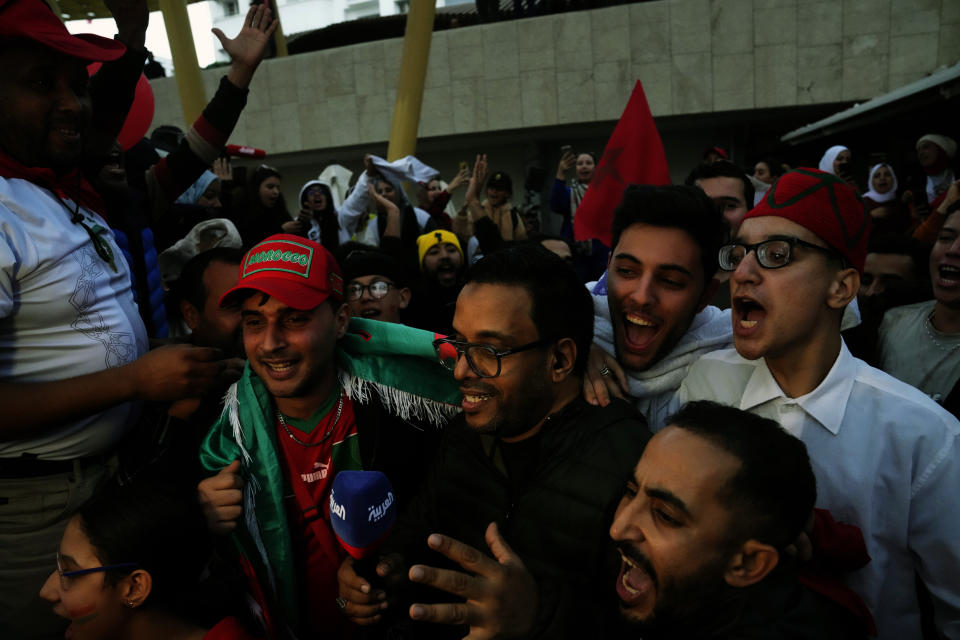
(402, 229, 466, 335)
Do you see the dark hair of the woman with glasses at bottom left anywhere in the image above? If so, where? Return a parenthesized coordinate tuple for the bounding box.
(79, 482, 213, 612)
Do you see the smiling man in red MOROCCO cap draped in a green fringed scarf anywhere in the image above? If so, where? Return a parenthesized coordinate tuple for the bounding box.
(199, 234, 456, 637)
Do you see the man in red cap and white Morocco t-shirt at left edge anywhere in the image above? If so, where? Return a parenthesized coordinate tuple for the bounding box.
(0, 0, 258, 638)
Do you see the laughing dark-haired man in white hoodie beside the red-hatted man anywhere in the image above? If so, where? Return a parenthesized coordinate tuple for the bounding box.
(585, 185, 733, 430)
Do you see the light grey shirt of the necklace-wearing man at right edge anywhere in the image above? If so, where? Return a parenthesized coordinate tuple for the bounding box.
(878, 300, 960, 404)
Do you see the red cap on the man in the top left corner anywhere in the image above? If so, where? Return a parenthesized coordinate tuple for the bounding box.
(0, 0, 126, 62)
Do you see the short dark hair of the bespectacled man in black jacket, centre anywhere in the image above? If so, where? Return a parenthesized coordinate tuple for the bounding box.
(467, 244, 593, 376)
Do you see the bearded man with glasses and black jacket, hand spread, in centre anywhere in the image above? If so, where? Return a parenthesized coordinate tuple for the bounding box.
(340, 245, 649, 638)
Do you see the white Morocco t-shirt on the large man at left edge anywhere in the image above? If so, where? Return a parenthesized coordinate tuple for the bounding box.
(0, 178, 148, 460)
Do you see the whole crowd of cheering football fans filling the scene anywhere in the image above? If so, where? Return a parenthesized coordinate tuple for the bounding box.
(0, 0, 960, 640)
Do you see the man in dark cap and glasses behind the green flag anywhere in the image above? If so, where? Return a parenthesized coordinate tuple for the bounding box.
(343, 248, 410, 323)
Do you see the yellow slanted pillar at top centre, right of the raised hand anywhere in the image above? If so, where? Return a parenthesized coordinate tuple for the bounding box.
(387, 0, 436, 161)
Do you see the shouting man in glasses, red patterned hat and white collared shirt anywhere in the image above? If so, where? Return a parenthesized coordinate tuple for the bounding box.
(679, 169, 960, 638)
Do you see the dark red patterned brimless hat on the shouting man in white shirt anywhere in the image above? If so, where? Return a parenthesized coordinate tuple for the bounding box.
(743, 168, 870, 273)
